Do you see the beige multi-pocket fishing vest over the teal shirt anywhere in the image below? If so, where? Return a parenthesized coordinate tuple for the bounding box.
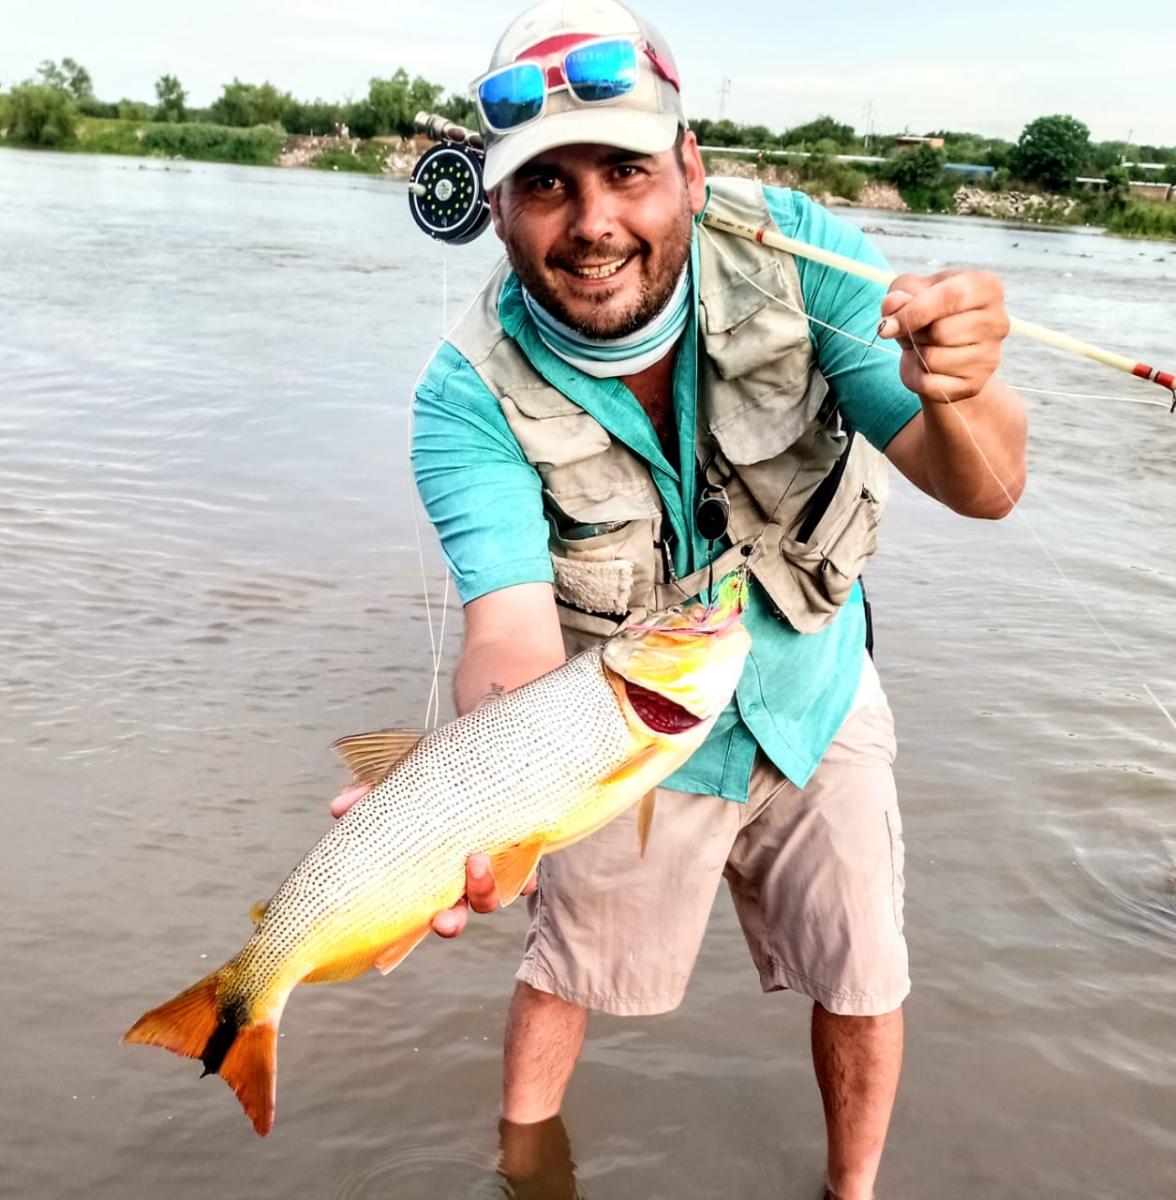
(449, 179, 888, 653)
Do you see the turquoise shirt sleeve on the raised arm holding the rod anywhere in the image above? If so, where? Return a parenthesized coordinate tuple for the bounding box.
(764, 187, 920, 450)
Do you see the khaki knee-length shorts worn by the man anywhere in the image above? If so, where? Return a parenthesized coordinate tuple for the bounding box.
(516, 658, 911, 1015)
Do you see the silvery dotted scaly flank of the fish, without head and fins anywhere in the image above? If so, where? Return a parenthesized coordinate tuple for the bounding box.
(232, 648, 636, 989)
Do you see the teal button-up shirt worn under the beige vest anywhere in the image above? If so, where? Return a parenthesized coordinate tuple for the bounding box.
(413, 188, 919, 802)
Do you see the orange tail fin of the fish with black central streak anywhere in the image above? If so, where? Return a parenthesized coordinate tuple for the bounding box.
(122, 967, 277, 1138)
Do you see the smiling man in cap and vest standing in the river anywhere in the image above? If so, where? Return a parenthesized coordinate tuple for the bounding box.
(335, 0, 1026, 1200)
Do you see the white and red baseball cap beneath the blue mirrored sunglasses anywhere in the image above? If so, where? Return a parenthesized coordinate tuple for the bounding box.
(484, 0, 688, 187)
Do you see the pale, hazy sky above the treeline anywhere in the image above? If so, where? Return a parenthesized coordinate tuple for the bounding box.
(9, 0, 1176, 145)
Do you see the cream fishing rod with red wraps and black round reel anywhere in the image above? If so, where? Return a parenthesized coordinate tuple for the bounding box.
(408, 113, 1176, 413)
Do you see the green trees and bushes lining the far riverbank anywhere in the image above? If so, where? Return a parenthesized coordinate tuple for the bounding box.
(0, 58, 1176, 238)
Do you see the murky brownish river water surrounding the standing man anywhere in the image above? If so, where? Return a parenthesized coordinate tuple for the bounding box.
(0, 151, 1176, 1200)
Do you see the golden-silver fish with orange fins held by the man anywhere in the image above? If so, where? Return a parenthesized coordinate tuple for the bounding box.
(122, 575, 751, 1136)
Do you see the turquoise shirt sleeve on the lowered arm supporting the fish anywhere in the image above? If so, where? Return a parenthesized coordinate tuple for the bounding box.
(413, 343, 553, 604)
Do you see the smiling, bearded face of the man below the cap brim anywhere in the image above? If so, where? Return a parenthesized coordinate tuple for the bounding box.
(490, 132, 706, 337)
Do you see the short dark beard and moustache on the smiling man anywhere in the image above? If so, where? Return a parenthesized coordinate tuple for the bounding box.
(506, 191, 694, 338)
